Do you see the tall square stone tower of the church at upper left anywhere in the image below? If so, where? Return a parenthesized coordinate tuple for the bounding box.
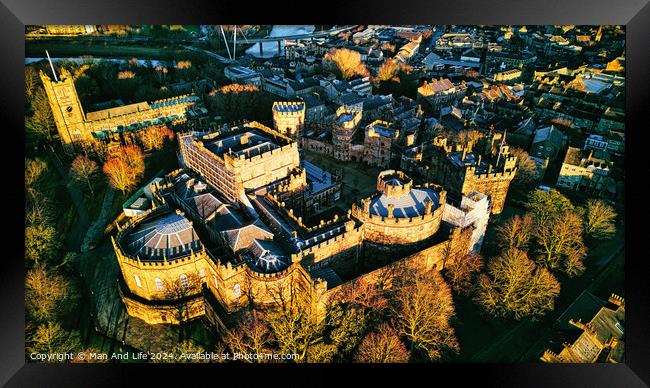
(40, 69, 91, 146)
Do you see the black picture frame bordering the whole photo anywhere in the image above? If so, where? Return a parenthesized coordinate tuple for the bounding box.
(0, 0, 650, 387)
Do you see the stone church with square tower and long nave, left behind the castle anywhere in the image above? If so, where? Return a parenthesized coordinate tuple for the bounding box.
(40, 68, 207, 151)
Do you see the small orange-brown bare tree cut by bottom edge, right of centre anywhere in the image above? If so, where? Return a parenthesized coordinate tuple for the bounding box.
(355, 324, 409, 363)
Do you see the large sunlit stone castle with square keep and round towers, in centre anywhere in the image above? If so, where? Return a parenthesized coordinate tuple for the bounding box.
(113, 119, 489, 328)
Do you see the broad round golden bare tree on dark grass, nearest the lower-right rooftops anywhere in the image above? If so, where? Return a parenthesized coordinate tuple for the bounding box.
(475, 249, 560, 319)
